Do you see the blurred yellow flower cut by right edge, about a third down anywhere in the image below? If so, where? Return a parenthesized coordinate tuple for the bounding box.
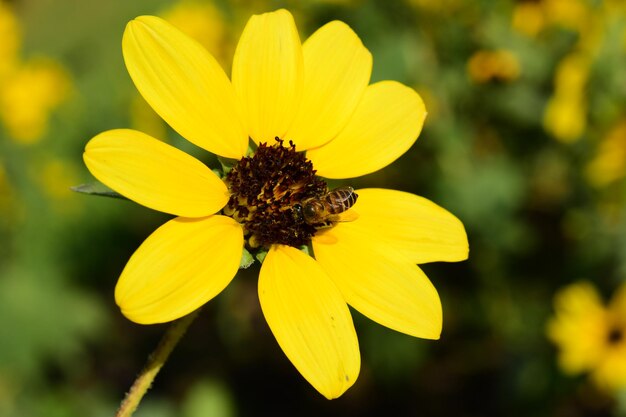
(585, 120, 626, 187)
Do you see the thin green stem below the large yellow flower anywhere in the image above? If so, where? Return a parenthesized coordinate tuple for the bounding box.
(115, 309, 200, 417)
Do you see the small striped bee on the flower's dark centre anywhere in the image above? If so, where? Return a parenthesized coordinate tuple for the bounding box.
(293, 186, 358, 224)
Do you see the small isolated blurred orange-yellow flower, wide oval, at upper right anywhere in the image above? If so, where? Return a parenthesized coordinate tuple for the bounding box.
(467, 49, 520, 83)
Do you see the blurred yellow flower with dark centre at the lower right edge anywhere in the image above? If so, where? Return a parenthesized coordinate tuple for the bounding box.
(547, 282, 626, 391)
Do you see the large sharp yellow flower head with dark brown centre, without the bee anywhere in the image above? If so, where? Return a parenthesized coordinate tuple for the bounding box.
(84, 10, 468, 399)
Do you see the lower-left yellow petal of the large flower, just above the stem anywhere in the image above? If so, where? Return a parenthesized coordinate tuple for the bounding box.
(115, 216, 243, 324)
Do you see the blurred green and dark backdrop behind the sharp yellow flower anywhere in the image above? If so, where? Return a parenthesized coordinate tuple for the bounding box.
(0, 0, 626, 417)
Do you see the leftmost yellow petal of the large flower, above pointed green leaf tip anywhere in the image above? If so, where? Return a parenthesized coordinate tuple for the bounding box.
(83, 129, 228, 217)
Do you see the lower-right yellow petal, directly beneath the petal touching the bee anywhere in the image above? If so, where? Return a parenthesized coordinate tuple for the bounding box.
(313, 223, 442, 339)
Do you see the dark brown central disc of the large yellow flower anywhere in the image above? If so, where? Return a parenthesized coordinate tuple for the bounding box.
(224, 138, 328, 248)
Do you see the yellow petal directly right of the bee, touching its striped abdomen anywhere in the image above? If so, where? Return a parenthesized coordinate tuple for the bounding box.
(353, 188, 469, 264)
